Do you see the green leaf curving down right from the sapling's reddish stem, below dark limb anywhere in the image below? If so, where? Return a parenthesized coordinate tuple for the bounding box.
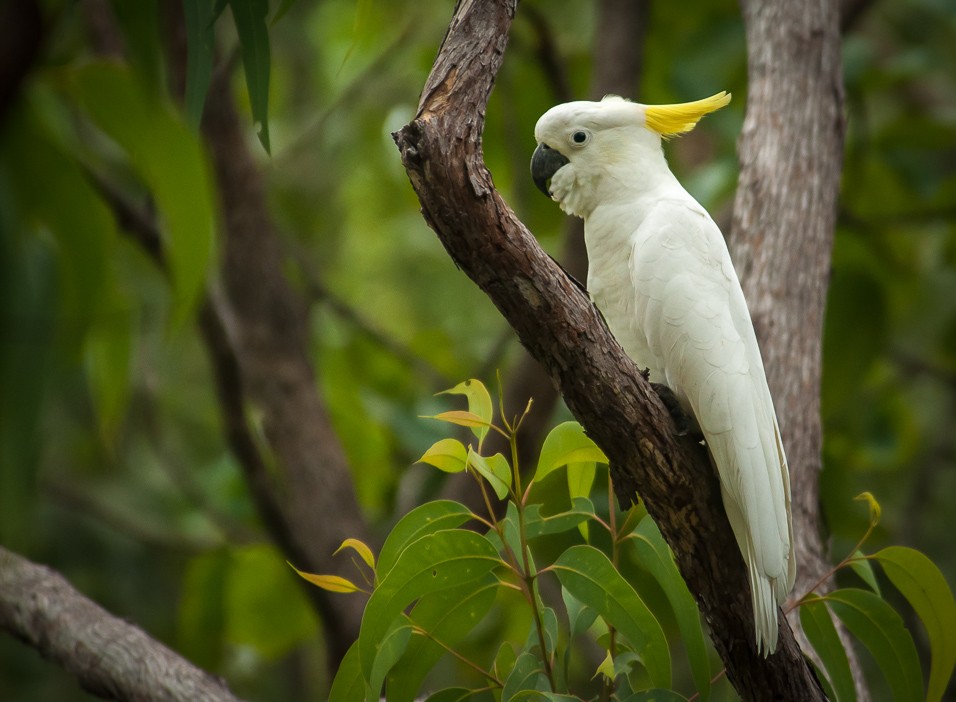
(551, 546, 671, 687)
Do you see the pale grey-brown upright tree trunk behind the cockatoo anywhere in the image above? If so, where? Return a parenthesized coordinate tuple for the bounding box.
(730, 0, 866, 699)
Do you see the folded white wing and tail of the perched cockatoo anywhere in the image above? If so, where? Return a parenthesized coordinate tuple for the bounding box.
(631, 200, 795, 643)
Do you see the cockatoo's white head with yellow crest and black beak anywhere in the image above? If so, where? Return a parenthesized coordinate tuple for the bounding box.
(531, 92, 730, 217)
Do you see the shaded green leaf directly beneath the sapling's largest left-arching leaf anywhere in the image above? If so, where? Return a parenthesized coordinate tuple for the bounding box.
(386, 574, 499, 702)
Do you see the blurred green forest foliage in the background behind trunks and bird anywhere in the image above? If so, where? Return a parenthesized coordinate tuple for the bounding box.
(0, 0, 956, 702)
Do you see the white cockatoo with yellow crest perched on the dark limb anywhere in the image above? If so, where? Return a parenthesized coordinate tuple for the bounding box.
(531, 92, 795, 656)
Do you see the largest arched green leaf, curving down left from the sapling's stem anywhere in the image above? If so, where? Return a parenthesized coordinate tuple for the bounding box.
(359, 529, 501, 695)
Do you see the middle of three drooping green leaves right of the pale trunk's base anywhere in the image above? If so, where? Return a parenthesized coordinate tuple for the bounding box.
(823, 588, 923, 702)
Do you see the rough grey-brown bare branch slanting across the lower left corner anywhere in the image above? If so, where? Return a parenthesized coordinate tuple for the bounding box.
(0, 547, 238, 702)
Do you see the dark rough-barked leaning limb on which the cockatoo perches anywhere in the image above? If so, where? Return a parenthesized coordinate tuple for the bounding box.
(395, 0, 823, 700)
